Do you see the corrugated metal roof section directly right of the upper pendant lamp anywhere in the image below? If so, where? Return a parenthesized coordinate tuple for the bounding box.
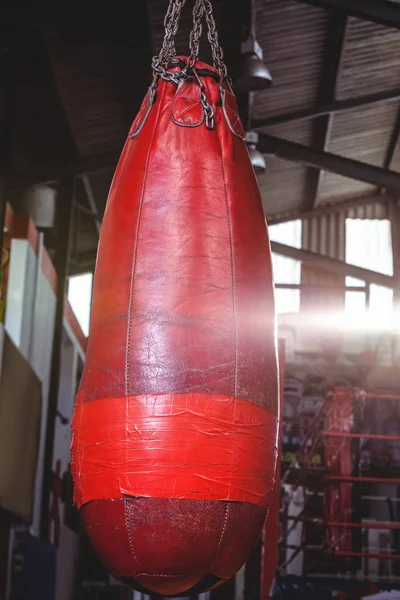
(253, 0, 329, 119)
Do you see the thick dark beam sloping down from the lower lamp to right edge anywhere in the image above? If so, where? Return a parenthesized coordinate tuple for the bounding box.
(258, 134, 400, 194)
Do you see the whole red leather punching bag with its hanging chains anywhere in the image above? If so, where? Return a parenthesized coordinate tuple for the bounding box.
(71, 0, 278, 596)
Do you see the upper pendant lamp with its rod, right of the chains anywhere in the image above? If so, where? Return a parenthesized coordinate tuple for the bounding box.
(235, 0, 272, 92)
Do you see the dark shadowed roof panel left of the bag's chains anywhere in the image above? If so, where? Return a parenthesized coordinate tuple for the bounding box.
(46, 3, 150, 156)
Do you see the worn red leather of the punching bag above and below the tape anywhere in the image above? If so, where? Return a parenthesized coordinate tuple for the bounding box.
(74, 58, 278, 595)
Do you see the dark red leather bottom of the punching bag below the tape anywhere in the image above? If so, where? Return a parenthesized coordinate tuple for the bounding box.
(81, 498, 265, 595)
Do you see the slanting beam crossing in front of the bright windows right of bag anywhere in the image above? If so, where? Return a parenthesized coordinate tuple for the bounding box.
(271, 242, 395, 289)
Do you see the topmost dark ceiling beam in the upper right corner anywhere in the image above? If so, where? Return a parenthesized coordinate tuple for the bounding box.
(297, 0, 400, 29)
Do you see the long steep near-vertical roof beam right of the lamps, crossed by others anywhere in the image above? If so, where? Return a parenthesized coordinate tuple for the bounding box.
(308, 11, 348, 208)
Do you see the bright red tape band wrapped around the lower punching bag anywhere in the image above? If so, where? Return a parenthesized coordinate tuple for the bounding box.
(71, 394, 278, 508)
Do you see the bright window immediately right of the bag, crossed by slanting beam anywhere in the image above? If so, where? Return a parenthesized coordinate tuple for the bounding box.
(269, 220, 301, 314)
